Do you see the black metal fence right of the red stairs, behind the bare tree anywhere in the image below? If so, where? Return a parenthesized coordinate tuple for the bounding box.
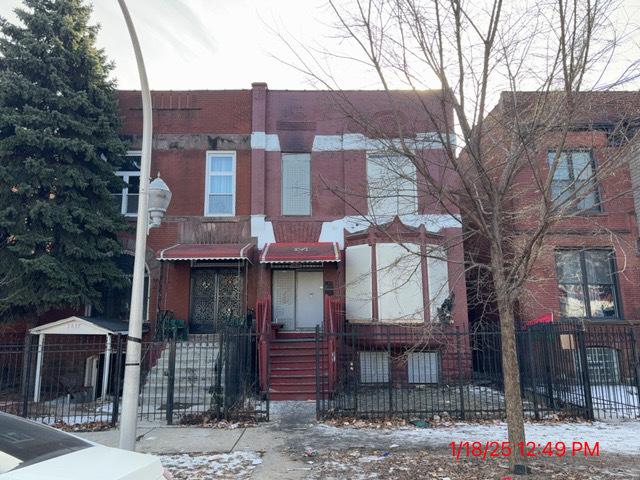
(316, 324, 640, 419)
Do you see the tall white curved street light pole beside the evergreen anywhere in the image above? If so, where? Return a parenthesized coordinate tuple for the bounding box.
(118, 0, 153, 450)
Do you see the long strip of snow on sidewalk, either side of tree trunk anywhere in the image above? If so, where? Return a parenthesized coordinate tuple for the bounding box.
(314, 421, 640, 455)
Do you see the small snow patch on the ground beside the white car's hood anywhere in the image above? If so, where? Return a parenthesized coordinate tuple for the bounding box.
(160, 451, 262, 480)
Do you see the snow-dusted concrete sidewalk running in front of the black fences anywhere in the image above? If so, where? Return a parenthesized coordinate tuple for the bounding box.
(80, 402, 640, 480)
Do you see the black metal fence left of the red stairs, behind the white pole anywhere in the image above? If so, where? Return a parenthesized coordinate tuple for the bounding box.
(0, 323, 269, 425)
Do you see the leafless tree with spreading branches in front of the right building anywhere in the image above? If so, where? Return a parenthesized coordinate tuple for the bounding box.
(285, 0, 638, 473)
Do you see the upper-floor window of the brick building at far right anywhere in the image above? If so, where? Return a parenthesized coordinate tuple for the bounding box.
(548, 150, 600, 211)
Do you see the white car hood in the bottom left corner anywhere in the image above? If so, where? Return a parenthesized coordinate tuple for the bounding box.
(0, 446, 162, 480)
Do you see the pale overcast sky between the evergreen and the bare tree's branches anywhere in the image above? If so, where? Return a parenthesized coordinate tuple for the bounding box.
(0, 0, 640, 90)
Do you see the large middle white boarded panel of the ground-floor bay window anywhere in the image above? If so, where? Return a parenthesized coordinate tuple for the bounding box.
(376, 243, 424, 322)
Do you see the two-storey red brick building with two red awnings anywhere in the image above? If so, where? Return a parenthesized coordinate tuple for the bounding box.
(112, 83, 467, 398)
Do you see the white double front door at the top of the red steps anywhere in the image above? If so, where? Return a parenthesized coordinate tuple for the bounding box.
(272, 270, 324, 330)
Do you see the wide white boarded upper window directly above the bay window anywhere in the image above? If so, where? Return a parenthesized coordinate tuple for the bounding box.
(367, 153, 418, 217)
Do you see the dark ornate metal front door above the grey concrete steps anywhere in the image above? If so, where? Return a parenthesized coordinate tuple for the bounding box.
(189, 268, 243, 333)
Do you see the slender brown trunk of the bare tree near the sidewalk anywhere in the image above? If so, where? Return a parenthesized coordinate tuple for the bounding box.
(496, 290, 527, 474)
